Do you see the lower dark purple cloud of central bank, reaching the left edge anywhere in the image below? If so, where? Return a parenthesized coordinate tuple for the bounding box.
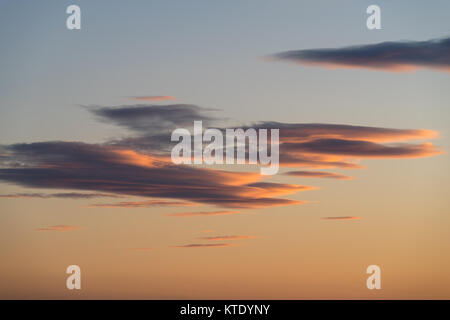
(0, 142, 307, 209)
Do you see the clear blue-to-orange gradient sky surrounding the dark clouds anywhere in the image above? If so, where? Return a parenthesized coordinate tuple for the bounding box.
(0, 1, 450, 299)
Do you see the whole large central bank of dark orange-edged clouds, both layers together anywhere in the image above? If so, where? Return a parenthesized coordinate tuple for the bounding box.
(0, 104, 440, 212)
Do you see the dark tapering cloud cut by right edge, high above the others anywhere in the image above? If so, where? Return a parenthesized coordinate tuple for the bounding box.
(272, 37, 450, 72)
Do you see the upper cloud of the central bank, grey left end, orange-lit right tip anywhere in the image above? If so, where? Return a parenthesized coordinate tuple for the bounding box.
(85, 104, 439, 169)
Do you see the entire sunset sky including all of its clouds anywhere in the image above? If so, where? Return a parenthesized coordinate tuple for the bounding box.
(0, 0, 450, 299)
